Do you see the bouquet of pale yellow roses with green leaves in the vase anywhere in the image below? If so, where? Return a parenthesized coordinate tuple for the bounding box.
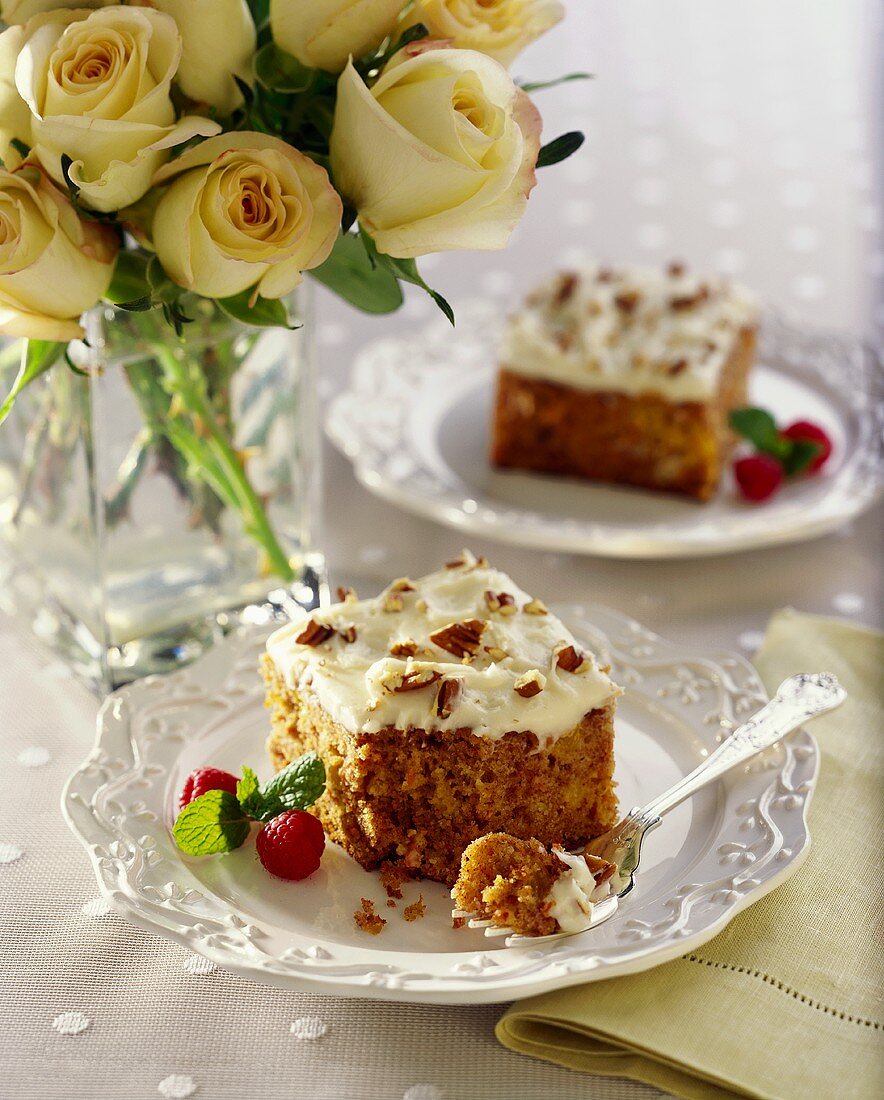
(0, 0, 582, 574)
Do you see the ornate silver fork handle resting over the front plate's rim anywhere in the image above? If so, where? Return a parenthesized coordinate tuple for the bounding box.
(639, 672, 847, 824)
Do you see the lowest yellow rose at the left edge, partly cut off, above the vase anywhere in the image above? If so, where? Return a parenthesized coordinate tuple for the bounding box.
(0, 164, 118, 340)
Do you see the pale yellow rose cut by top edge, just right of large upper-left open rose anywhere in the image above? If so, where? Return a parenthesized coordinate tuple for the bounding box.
(136, 0, 256, 114)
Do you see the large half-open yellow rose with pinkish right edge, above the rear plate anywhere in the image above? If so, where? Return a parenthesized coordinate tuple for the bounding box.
(331, 43, 541, 259)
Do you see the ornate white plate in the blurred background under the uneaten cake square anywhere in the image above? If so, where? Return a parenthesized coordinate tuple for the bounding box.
(325, 305, 884, 559)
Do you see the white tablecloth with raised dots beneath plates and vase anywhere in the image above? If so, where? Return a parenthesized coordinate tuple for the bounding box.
(0, 0, 884, 1100)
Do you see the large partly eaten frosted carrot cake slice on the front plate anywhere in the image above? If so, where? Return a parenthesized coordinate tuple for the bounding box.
(263, 552, 620, 886)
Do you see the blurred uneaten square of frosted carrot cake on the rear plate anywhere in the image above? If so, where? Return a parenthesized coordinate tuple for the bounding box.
(491, 263, 758, 501)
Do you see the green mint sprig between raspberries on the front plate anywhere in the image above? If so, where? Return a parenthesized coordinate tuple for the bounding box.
(172, 752, 325, 856)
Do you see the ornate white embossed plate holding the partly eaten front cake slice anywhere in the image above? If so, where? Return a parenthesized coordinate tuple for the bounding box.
(63, 607, 818, 1003)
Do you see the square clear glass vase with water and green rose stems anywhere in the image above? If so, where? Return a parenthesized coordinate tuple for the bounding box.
(0, 289, 324, 692)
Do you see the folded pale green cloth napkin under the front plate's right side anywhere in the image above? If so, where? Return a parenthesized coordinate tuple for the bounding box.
(497, 611, 884, 1100)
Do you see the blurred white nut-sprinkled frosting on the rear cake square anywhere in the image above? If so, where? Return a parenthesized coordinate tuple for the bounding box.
(499, 264, 759, 402)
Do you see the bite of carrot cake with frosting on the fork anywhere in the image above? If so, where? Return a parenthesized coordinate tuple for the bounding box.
(451, 833, 617, 936)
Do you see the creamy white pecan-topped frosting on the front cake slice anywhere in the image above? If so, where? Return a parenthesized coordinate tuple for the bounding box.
(267, 551, 620, 744)
